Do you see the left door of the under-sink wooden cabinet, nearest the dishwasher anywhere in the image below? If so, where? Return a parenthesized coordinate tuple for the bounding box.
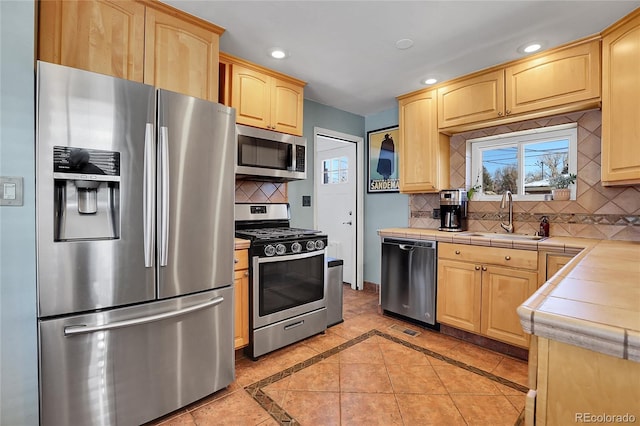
(436, 259, 480, 333)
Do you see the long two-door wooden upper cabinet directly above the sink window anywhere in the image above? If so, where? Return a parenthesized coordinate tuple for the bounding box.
(438, 39, 600, 132)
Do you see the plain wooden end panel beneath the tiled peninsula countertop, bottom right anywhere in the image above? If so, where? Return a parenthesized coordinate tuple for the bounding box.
(525, 337, 640, 426)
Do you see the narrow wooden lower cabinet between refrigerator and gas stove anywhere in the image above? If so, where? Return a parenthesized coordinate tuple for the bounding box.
(234, 250, 249, 349)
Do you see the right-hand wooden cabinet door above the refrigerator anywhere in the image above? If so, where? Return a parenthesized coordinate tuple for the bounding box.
(144, 7, 219, 102)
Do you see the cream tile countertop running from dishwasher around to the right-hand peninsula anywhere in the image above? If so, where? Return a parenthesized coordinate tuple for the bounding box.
(378, 228, 640, 362)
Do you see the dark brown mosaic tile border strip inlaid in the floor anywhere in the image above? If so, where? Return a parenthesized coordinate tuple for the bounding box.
(244, 329, 528, 426)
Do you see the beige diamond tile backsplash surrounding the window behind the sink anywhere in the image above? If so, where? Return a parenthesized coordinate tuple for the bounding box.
(409, 110, 640, 241)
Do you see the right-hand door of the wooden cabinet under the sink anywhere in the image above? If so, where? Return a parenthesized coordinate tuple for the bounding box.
(481, 265, 538, 348)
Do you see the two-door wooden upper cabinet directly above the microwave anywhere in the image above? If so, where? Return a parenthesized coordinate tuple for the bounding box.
(221, 54, 305, 136)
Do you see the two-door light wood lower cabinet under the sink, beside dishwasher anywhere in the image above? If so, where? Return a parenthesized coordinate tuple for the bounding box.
(436, 243, 538, 348)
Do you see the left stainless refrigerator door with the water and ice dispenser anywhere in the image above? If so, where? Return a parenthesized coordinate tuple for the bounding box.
(36, 62, 155, 317)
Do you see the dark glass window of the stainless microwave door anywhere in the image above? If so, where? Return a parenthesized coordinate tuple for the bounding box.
(238, 135, 293, 170)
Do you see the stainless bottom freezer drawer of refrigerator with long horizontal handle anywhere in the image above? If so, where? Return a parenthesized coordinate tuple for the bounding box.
(39, 287, 234, 426)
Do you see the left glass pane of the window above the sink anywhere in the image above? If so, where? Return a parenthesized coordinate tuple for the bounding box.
(482, 146, 518, 195)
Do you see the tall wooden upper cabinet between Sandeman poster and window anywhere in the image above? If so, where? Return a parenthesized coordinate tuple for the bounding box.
(398, 90, 449, 193)
